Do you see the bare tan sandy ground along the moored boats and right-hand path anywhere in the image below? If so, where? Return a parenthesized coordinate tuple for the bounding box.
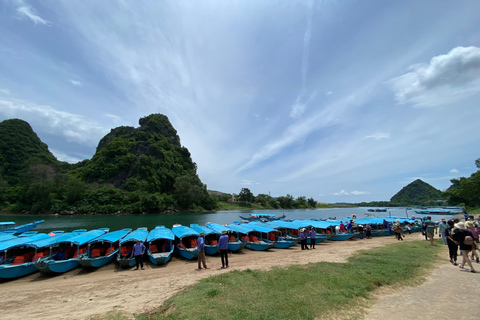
(0, 234, 472, 319)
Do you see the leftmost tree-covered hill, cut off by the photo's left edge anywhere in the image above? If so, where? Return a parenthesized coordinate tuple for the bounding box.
(0, 119, 59, 186)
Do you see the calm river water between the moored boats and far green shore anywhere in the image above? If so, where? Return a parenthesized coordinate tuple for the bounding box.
(0, 208, 451, 232)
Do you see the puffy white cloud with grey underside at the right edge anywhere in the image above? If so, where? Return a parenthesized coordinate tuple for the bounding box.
(389, 46, 480, 107)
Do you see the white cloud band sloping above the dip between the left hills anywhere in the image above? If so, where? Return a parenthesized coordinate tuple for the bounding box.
(0, 92, 109, 145)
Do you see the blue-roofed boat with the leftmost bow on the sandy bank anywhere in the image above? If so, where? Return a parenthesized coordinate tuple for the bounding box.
(0, 230, 93, 279)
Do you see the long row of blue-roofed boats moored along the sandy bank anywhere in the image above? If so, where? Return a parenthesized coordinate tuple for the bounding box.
(0, 218, 416, 278)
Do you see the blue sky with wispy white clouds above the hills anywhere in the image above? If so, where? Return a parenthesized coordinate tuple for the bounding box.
(0, 0, 480, 202)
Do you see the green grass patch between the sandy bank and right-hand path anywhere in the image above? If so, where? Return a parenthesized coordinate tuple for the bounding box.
(138, 241, 441, 320)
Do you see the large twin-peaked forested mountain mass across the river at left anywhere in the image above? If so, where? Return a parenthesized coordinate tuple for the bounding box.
(0, 114, 216, 214)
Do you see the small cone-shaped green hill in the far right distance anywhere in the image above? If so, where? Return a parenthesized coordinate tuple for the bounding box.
(390, 179, 442, 206)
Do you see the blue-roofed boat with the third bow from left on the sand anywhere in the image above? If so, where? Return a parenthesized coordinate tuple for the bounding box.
(78, 228, 132, 268)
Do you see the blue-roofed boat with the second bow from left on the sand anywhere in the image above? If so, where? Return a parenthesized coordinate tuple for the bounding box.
(35, 228, 108, 273)
